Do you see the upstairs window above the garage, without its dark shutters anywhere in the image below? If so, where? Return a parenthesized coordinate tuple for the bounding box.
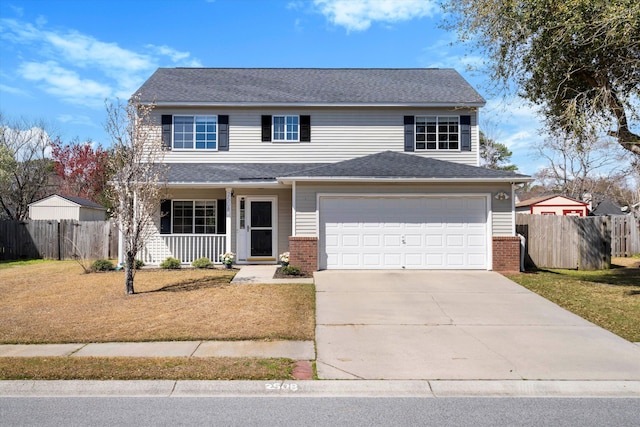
(416, 116, 460, 150)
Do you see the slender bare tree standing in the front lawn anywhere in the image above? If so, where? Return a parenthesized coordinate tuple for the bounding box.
(105, 95, 166, 294)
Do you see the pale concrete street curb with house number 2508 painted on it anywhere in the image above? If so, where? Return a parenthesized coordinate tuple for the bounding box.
(0, 380, 640, 398)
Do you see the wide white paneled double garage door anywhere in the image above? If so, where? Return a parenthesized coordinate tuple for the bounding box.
(320, 196, 488, 269)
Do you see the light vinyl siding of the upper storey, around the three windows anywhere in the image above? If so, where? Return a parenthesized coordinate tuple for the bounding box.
(155, 108, 478, 166)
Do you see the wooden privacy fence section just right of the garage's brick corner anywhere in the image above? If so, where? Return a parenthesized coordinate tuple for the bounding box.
(516, 214, 611, 270)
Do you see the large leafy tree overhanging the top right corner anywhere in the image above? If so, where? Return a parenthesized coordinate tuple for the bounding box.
(443, 0, 640, 155)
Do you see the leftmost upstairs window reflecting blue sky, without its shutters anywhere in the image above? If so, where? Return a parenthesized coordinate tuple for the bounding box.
(173, 116, 218, 150)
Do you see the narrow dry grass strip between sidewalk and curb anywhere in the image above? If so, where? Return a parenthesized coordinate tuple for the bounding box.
(0, 357, 295, 380)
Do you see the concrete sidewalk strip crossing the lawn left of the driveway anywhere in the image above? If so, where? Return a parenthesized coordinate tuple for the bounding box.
(0, 341, 316, 360)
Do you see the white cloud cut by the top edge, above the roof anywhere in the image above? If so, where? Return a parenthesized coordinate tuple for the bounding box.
(314, 0, 438, 31)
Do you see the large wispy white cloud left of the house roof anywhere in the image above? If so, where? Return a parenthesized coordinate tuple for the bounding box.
(0, 19, 202, 108)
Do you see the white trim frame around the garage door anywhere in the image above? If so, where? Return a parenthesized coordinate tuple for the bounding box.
(315, 192, 493, 270)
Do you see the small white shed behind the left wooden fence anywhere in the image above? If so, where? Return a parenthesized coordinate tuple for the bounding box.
(29, 194, 107, 221)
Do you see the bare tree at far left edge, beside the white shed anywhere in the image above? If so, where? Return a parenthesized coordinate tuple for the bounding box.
(0, 113, 53, 221)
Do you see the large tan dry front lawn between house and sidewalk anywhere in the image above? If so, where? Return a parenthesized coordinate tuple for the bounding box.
(0, 261, 315, 343)
